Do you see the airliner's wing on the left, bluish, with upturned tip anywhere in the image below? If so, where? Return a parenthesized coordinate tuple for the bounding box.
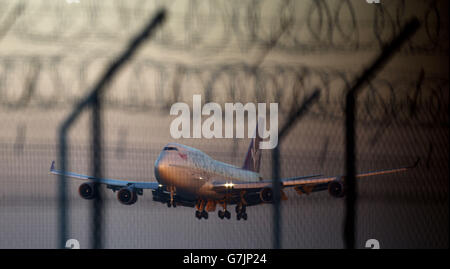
(50, 161, 159, 190)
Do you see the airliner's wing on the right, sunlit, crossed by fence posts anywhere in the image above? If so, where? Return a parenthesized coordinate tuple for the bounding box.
(213, 157, 419, 194)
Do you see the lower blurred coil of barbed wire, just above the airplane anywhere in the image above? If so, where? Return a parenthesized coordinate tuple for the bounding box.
(0, 55, 449, 126)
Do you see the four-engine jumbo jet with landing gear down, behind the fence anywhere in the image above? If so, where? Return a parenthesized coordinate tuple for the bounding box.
(50, 122, 420, 220)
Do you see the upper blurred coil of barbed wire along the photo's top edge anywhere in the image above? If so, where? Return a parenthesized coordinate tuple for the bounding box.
(0, 0, 448, 54)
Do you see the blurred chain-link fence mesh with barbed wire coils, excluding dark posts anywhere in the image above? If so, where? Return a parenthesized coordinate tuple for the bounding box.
(0, 0, 449, 248)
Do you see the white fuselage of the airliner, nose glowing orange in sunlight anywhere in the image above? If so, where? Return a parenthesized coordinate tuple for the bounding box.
(155, 143, 261, 200)
